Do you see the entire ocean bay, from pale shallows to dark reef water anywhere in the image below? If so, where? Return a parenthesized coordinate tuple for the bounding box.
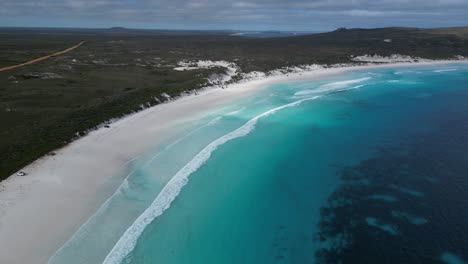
(50, 64, 468, 264)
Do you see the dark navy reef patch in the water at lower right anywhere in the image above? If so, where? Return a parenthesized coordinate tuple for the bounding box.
(316, 111, 468, 264)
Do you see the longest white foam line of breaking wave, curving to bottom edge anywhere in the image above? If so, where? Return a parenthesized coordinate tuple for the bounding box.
(103, 96, 320, 264)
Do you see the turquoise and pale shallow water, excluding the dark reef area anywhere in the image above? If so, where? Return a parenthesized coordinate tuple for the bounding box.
(51, 64, 468, 264)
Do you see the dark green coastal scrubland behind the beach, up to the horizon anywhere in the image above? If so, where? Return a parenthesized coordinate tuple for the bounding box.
(0, 25, 468, 180)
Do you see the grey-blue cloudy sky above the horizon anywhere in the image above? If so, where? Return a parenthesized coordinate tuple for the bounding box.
(0, 0, 468, 31)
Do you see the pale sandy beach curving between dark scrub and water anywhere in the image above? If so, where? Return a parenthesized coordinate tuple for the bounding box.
(0, 61, 467, 264)
